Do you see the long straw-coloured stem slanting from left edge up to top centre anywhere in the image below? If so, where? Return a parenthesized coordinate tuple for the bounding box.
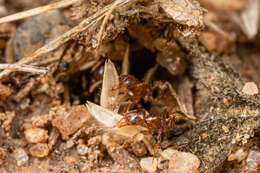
(0, 0, 136, 79)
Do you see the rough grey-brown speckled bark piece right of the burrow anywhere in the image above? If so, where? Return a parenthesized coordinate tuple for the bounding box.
(172, 33, 260, 173)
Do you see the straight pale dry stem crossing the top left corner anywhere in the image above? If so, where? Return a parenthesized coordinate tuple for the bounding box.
(0, 0, 79, 24)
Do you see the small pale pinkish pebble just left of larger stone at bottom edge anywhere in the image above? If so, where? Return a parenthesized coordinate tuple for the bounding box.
(140, 157, 158, 172)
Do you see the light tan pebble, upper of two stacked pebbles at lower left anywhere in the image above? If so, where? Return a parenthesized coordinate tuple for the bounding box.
(24, 128, 49, 143)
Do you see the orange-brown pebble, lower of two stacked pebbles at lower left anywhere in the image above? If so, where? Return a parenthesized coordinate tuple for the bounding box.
(29, 143, 49, 157)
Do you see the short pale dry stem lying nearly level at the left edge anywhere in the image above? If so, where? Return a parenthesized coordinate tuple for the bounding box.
(0, 64, 48, 74)
